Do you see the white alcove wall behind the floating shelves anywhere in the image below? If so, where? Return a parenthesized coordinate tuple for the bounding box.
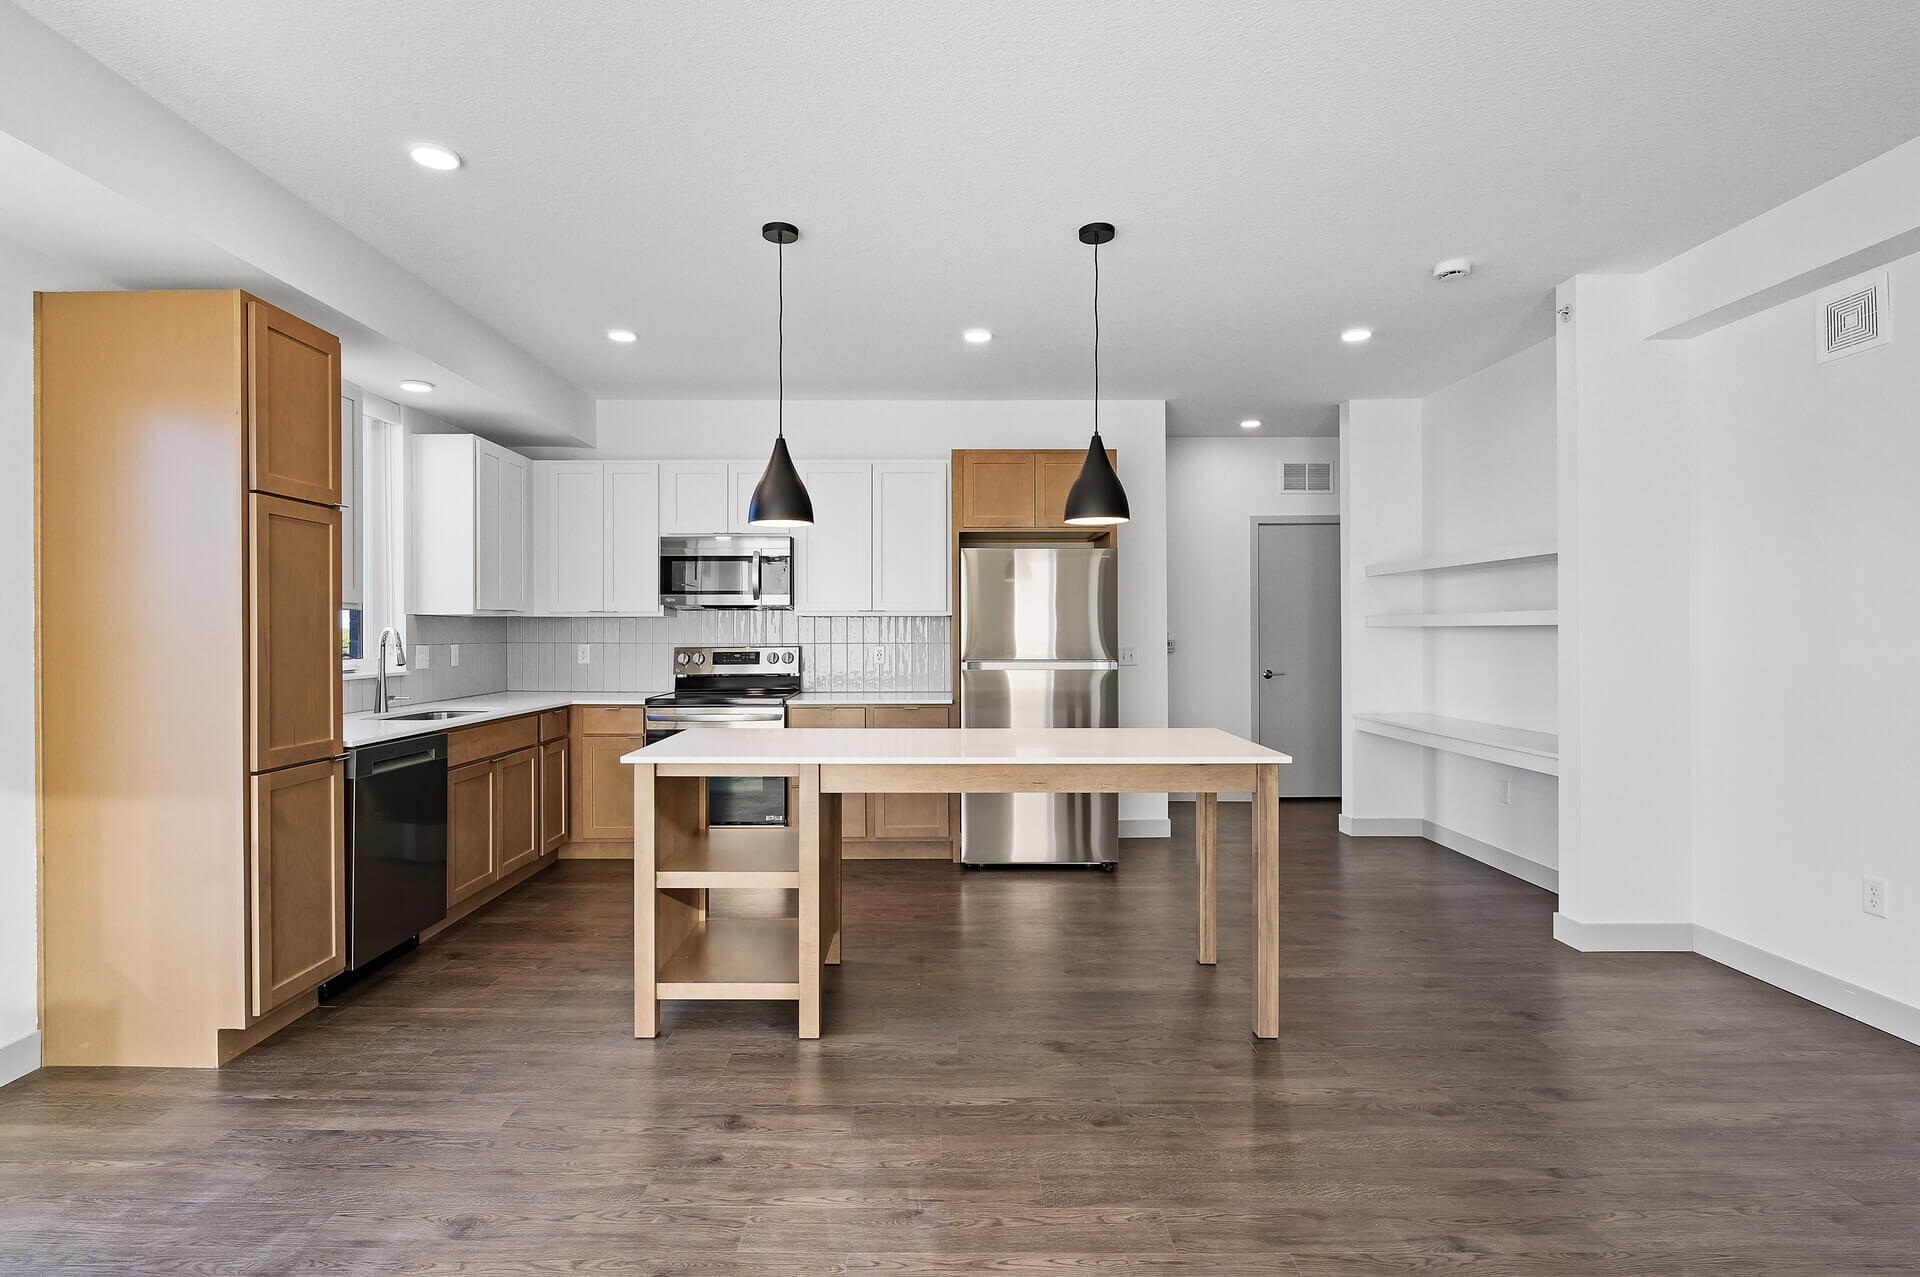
(1407, 338, 1559, 881)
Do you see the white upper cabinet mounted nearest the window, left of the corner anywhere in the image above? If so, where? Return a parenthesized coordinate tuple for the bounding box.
(407, 434, 528, 616)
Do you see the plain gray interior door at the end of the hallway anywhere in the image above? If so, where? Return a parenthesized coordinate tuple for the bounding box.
(1254, 522, 1340, 799)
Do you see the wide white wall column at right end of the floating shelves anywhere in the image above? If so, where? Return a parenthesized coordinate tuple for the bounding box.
(1553, 275, 1693, 951)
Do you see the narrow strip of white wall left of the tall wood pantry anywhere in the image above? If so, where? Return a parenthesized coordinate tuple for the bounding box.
(0, 240, 106, 1085)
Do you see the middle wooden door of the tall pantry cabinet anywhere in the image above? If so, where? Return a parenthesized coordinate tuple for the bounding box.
(248, 494, 344, 772)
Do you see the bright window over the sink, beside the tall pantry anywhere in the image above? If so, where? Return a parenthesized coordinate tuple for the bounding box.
(340, 394, 407, 678)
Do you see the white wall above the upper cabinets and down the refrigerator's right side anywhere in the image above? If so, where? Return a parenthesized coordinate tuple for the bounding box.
(528, 399, 1167, 835)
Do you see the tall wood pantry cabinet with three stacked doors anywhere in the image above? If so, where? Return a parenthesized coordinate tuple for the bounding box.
(35, 292, 346, 1066)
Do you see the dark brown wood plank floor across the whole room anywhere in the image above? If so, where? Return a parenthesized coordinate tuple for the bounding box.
(0, 803, 1920, 1277)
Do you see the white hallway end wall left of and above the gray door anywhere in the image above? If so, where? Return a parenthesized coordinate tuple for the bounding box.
(1167, 438, 1340, 752)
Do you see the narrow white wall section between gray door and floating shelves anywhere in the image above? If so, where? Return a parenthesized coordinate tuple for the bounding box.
(1340, 399, 1430, 837)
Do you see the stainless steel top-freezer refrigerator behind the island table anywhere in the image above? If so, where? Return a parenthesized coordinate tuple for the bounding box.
(960, 545, 1119, 868)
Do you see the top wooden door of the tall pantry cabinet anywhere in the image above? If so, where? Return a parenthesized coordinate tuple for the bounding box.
(246, 301, 340, 505)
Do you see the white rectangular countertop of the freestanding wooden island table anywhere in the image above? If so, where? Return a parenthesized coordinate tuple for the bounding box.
(620, 728, 1292, 766)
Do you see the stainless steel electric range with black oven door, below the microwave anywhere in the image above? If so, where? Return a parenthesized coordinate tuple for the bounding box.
(647, 647, 801, 826)
